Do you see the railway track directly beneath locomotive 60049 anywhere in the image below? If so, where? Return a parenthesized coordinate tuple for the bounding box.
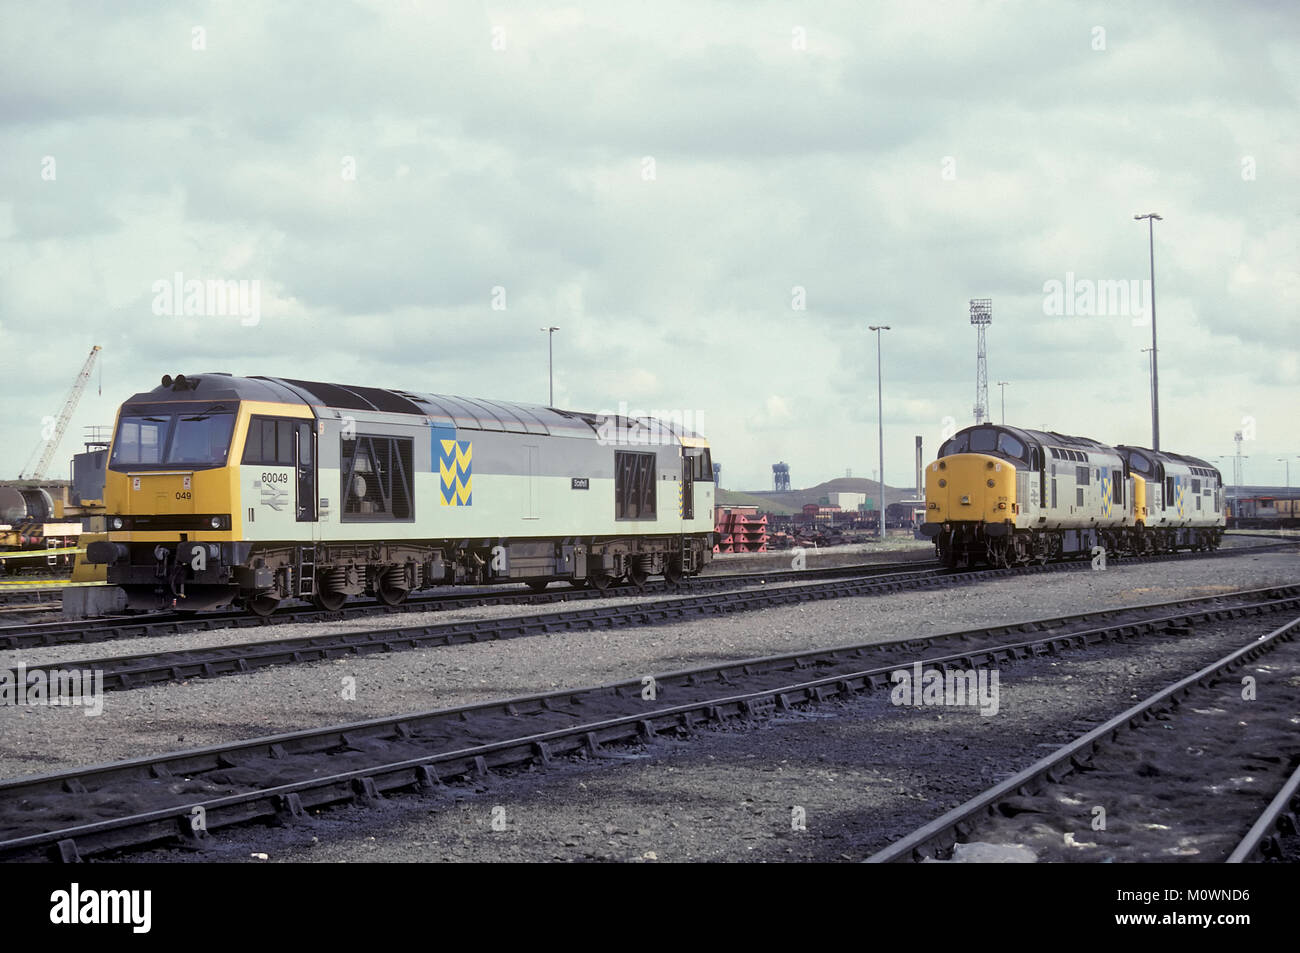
(0, 559, 939, 651)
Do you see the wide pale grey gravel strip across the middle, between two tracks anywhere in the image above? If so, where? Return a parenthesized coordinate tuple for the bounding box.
(0, 543, 1300, 859)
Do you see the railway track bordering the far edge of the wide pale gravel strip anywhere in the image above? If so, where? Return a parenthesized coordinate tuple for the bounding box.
(12, 538, 1300, 692)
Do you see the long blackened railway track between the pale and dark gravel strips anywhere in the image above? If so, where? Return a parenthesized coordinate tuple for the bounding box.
(0, 577, 1300, 861)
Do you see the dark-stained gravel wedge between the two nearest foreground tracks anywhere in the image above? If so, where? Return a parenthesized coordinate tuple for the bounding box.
(129, 608, 1281, 863)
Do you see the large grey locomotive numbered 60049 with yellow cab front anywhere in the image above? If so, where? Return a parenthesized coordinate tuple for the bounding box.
(87, 373, 714, 615)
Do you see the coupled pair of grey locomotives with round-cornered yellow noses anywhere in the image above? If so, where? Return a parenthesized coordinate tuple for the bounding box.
(920, 424, 1225, 567)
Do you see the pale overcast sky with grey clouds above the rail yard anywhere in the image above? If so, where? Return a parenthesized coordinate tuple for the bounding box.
(0, 0, 1300, 489)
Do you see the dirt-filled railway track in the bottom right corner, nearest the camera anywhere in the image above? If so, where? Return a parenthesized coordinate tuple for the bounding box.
(868, 608, 1300, 863)
